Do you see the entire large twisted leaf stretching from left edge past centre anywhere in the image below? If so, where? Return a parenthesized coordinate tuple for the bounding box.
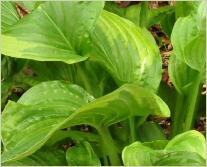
(2, 81, 170, 162)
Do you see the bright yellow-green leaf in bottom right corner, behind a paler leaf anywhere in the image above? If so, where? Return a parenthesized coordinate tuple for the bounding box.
(165, 130, 206, 159)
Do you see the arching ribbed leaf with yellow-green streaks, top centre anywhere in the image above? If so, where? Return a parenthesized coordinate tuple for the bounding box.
(92, 11, 161, 90)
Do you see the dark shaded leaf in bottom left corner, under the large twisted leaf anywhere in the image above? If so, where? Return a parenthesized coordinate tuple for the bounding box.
(2, 148, 67, 166)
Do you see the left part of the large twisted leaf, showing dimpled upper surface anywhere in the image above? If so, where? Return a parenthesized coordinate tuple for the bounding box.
(2, 81, 92, 162)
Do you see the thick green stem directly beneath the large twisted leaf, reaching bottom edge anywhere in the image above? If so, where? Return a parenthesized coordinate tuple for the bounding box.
(97, 127, 121, 166)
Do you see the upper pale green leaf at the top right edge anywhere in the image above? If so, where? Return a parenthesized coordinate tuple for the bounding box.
(171, 3, 206, 64)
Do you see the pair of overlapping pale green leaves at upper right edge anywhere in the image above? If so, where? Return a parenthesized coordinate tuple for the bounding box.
(169, 2, 206, 93)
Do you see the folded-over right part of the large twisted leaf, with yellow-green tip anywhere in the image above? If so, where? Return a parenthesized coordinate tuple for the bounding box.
(61, 84, 170, 128)
